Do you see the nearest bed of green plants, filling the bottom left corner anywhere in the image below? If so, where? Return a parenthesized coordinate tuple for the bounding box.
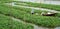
(0, 14, 34, 29)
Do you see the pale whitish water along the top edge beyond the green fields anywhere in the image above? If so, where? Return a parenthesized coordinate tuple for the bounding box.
(14, 0, 60, 5)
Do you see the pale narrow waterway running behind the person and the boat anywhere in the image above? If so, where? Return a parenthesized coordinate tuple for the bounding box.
(6, 2, 60, 13)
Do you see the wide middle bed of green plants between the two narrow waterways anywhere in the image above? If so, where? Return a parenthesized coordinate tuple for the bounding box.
(0, 5, 60, 27)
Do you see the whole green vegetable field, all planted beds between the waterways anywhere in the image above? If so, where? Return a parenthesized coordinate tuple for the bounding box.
(0, 0, 60, 29)
